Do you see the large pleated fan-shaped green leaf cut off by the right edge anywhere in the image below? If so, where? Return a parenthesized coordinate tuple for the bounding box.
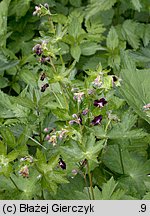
(120, 69, 150, 123)
